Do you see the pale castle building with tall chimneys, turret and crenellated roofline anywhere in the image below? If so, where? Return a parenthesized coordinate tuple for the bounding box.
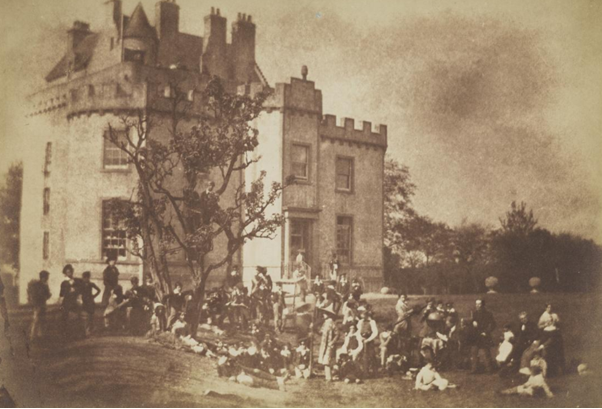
(20, 0, 387, 302)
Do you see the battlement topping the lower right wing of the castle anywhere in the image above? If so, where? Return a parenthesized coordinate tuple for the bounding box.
(320, 115, 388, 148)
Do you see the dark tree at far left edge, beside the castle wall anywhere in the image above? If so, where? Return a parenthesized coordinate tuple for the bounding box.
(0, 162, 23, 271)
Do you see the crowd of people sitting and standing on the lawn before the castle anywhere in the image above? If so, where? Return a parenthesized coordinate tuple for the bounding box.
(19, 258, 566, 396)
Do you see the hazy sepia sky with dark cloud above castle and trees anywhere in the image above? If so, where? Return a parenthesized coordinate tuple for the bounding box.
(0, 0, 602, 243)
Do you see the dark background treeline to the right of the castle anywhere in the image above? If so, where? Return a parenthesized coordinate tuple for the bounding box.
(385, 158, 602, 294)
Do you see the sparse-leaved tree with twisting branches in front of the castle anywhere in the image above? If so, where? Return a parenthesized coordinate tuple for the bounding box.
(105, 78, 284, 329)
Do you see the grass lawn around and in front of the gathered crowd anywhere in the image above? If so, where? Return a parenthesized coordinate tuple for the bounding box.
(0, 295, 602, 408)
